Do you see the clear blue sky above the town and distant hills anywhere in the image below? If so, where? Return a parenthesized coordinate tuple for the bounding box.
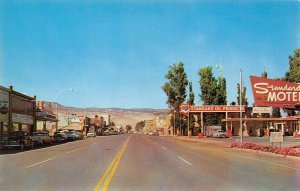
(0, 0, 300, 108)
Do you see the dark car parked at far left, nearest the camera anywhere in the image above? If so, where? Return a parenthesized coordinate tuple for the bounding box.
(2, 131, 33, 150)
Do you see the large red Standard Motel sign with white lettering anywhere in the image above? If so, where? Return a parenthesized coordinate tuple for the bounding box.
(250, 76, 300, 107)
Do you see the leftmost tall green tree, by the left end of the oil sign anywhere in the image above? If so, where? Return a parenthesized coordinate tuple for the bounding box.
(162, 62, 188, 133)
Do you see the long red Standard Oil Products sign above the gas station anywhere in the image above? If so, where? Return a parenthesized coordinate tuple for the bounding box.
(180, 104, 245, 113)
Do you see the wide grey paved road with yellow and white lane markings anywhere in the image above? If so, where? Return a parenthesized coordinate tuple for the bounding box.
(0, 135, 300, 191)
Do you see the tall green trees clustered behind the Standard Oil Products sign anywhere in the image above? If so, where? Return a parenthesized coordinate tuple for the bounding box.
(162, 62, 227, 134)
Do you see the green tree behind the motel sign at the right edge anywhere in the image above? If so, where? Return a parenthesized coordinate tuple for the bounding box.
(284, 49, 300, 83)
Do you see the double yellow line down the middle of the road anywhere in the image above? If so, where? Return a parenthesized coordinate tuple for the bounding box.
(94, 137, 130, 191)
